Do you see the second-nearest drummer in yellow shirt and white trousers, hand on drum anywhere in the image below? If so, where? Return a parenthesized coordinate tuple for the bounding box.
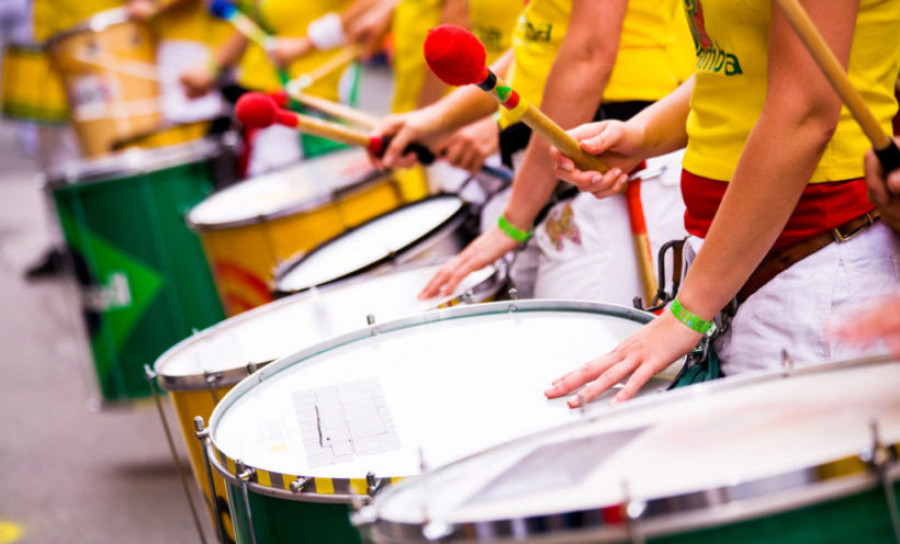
(382, 0, 691, 304)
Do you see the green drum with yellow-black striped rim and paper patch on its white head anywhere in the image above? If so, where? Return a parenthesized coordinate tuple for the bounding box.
(209, 300, 674, 543)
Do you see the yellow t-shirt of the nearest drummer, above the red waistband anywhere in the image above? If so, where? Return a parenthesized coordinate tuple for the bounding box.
(684, 0, 900, 183)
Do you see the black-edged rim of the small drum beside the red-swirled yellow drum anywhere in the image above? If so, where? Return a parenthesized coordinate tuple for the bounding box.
(272, 193, 469, 297)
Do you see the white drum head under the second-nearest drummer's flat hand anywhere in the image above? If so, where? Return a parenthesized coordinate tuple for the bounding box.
(155, 263, 504, 388)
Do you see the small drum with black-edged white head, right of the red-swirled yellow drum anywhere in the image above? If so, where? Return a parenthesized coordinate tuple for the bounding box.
(275, 195, 473, 296)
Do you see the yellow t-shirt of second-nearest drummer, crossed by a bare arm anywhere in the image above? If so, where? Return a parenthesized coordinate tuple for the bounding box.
(500, 0, 691, 128)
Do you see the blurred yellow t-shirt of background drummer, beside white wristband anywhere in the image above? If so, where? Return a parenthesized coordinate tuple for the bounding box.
(238, 0, 350, 100)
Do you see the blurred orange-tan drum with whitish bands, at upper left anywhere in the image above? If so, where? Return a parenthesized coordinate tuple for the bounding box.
(47, 9, 162, 157)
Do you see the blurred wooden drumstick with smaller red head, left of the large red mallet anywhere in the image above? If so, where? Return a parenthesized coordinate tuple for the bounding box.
(234, 93, 435, 164)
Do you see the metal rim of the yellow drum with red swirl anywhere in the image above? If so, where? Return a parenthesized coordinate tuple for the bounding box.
(185, 155, 393, 232)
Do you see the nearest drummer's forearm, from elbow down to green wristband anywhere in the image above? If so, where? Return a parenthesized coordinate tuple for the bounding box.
(679, 112, 829, 319)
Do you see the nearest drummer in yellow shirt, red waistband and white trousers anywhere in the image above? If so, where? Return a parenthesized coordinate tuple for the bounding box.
(545, 0, 900, 407)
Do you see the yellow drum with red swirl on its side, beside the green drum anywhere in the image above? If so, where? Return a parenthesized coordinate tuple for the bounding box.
(188, 149, 401, 315)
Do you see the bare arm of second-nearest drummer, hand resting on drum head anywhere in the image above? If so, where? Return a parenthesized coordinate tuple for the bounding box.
(419, 0, 627, 298)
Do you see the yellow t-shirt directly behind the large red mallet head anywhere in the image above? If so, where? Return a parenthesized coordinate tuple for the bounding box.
(391, 0, 523, 113)
